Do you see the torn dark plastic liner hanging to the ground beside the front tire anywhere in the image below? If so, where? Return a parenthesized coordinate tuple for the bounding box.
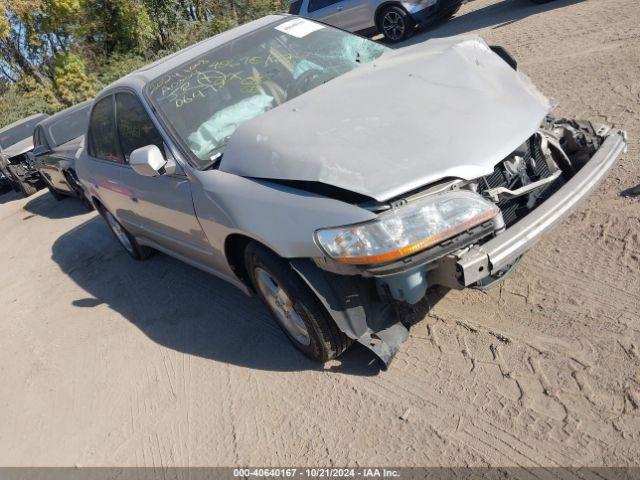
(290, 259, 409, 367)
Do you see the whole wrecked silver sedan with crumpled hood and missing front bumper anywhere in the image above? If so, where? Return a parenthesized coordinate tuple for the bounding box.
(76, 16, 626, 364)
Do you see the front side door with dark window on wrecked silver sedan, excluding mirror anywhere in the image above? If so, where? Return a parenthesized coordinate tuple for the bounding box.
(116, 91, 212, 263)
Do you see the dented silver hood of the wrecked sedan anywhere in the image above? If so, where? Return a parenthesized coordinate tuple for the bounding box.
(220, 36, 551, 201)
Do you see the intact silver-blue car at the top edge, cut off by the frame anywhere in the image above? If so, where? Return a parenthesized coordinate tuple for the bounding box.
(289, 0, 464, 42)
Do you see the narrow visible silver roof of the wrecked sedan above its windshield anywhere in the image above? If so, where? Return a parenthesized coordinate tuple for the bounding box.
(96, 14, 291, 98)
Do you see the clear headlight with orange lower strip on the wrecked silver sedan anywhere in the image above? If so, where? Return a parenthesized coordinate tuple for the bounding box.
(316, 190, 500, 264)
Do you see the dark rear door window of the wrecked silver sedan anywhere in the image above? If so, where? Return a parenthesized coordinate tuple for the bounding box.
(89, 95, 124, 163)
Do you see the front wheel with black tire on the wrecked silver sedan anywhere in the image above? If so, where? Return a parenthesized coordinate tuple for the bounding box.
(245, 242, 352, 362)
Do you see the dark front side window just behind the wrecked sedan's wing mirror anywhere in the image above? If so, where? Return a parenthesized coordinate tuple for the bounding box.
(116, 93, 164, 162)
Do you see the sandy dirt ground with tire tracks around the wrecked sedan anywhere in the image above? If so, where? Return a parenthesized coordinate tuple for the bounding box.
(0, 0, 640, 466)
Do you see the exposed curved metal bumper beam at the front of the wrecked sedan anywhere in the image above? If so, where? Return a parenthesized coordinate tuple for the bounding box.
(452, 131, 627, 286)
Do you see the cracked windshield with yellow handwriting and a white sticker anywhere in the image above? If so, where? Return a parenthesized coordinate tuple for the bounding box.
(147, 18, 387, 168)
